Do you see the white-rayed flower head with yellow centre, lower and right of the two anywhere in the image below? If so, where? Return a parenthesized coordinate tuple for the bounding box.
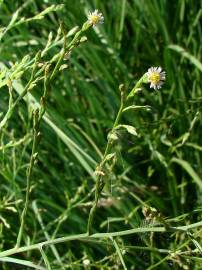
(146, 67, 166, 90)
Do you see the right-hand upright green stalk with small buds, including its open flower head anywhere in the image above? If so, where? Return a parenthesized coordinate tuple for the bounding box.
(87, 60, 166, 235)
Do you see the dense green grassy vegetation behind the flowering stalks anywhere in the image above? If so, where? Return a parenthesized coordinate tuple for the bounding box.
(0, 0, 202, 270)
